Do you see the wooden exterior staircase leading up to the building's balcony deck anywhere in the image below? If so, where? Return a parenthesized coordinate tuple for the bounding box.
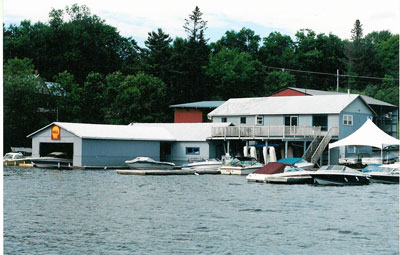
(302, 127, 337, 166)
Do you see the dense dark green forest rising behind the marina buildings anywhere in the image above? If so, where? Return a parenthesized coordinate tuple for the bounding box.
(3, 4, 399, 151)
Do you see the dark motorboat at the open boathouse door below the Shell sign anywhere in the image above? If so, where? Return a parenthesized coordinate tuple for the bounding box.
(31, 152, 72, 168)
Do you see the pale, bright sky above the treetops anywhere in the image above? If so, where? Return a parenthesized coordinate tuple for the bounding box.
(3, 0, 400, 46)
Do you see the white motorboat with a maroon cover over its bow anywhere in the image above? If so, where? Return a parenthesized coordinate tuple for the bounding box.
(246, 162, 313, 184)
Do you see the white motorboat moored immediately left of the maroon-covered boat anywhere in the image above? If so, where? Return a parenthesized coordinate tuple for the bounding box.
(219, 157, 264, 175)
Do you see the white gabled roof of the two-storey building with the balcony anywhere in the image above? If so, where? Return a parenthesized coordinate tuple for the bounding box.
(208, 94, 375, 117)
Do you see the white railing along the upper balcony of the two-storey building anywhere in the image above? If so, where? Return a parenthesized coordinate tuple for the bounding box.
(211, 126, 328, 138)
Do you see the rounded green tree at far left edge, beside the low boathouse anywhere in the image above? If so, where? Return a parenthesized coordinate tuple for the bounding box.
(3, 58, 48, 151)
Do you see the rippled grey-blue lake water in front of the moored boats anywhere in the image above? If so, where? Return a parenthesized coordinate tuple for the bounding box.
(4, 167, 399, 254)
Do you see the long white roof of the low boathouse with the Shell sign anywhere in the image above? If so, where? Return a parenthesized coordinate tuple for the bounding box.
(27, 122, 230, 141)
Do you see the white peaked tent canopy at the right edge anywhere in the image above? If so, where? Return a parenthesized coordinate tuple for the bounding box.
(329, 119, 400, 150)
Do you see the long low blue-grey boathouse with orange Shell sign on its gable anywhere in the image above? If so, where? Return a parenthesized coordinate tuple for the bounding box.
(27, 122, 230, 167)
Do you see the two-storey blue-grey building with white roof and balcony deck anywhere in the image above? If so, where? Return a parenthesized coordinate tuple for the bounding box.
(208, 94, 376, 163)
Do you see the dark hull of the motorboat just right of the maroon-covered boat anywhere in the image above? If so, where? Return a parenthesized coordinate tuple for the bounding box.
(311, 174, 369, 185)
